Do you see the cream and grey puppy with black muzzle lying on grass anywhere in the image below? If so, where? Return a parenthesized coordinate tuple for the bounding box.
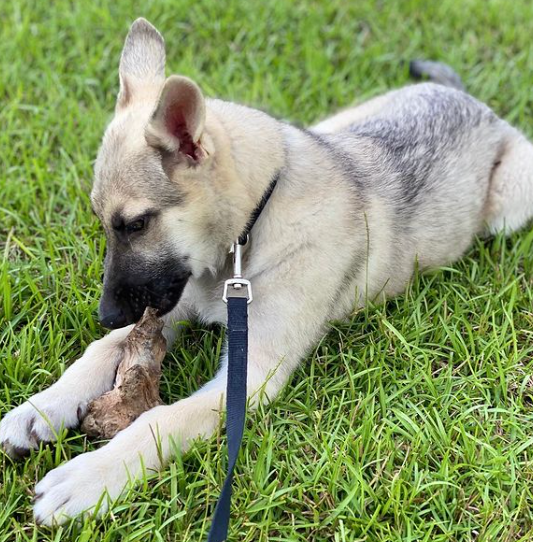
(0, 19, 533, 525)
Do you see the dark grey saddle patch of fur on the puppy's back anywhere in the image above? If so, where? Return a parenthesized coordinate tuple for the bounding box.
(341, 83, 499, 209)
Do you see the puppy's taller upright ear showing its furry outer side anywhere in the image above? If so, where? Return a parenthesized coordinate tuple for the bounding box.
(117, 18, 165, 109)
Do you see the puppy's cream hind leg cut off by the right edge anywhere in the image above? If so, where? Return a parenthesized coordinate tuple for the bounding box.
(485, 128, 533, 234)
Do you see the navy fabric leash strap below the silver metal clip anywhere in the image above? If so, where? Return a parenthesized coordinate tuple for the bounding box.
(207, 296, 248, 542)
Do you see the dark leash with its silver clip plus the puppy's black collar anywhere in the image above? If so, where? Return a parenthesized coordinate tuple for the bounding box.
(207, 172, 280, 542)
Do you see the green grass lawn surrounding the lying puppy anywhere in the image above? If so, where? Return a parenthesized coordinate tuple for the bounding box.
(0, 0, 533, 542)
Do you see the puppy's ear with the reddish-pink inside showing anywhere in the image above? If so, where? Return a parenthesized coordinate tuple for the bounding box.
(145, 75, 207, 163)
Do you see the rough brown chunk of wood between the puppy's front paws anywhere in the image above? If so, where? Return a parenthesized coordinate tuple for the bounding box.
(81, 307, 166, 439)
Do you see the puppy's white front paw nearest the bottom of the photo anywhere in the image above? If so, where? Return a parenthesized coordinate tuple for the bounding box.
(33, 447, 129, 525)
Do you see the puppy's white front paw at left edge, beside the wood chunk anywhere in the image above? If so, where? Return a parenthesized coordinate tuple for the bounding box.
(0, 388, 87, 458)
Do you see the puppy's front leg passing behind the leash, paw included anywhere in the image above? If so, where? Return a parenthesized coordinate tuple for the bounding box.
(31, 302, 318, 524)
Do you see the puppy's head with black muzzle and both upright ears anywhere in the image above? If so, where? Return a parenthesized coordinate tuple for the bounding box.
(91, 19, 223, 328)
